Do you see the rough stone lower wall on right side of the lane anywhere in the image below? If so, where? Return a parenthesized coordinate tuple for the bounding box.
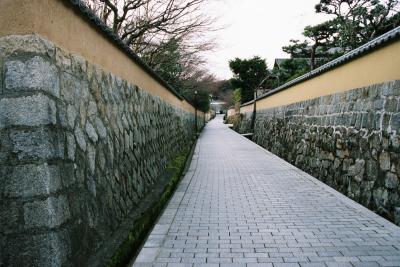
(235, 81, 400, 224)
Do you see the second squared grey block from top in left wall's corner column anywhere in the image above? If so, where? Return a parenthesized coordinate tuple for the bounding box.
(0, 94, 57, 129)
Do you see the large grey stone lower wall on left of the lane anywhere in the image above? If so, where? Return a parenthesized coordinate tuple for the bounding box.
(0, 35, 203, 266)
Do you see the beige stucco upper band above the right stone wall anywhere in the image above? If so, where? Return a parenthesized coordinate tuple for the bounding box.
(240, 41, 400, 113)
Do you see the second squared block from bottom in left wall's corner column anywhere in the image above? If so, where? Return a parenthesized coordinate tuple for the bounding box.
(24, 196, 70, 229)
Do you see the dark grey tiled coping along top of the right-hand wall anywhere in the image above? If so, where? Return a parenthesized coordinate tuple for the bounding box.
(241, 26, 400, 107)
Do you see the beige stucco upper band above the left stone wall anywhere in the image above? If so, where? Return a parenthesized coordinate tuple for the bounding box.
(0, 0, 203, 116)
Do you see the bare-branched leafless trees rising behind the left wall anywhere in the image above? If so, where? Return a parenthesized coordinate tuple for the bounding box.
(85, 0, 223, 109)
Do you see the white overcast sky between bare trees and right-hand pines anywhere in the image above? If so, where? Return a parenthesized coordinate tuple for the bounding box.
(205, 0, 329, 79)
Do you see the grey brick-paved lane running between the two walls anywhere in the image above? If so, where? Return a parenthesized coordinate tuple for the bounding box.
(133, 116, 400, 267)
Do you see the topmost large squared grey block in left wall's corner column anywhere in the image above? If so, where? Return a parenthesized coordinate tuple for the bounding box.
(4, 56, 60, 97)
